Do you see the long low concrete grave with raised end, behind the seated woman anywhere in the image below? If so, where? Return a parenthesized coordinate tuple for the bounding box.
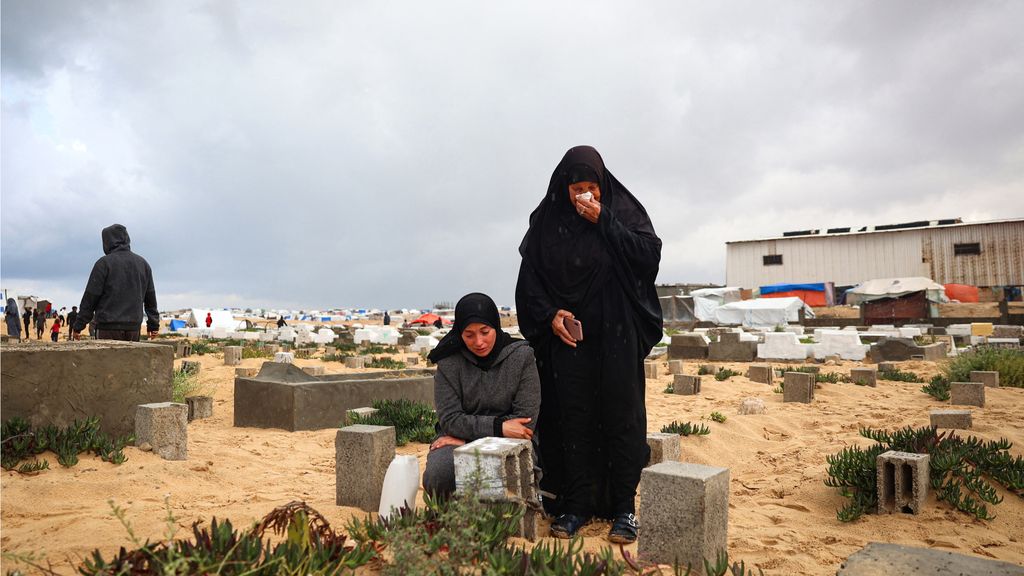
(234, 362, 434, 431)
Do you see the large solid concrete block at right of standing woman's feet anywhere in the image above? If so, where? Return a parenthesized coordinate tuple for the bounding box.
(637, 462, 729, 574)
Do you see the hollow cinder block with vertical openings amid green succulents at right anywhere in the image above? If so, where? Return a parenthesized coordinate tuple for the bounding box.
(876, 450, 930, 515)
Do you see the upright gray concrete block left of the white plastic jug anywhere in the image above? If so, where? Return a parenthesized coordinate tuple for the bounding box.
(334, 424, 394, 511)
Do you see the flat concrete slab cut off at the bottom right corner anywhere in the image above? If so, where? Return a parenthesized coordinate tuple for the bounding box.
(836, 542, 1024, 576)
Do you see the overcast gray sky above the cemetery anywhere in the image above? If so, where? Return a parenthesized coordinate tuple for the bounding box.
(0, 0, 1024, 310)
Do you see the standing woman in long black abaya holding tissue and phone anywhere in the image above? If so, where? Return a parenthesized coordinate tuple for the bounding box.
(516, 147, 663, 543)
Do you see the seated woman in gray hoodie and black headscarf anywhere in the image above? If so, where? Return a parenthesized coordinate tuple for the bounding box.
(423, 293, 541, 498)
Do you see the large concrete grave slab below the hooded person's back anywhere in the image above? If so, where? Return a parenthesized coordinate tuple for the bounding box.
(0, 340, 174, 437)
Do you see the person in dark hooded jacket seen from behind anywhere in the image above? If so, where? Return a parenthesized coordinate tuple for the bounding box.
(72, 224, 160, 342)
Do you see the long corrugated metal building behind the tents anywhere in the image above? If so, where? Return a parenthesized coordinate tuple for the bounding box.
(726, 218, 1024, 288)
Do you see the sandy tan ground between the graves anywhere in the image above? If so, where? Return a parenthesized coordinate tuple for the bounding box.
(0, 340, 1024, 574)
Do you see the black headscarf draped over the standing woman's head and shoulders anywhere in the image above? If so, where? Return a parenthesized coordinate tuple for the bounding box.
(517, 146, 662, 351)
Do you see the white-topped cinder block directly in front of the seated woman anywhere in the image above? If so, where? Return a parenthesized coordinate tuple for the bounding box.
(455, 438, 537, 502)
